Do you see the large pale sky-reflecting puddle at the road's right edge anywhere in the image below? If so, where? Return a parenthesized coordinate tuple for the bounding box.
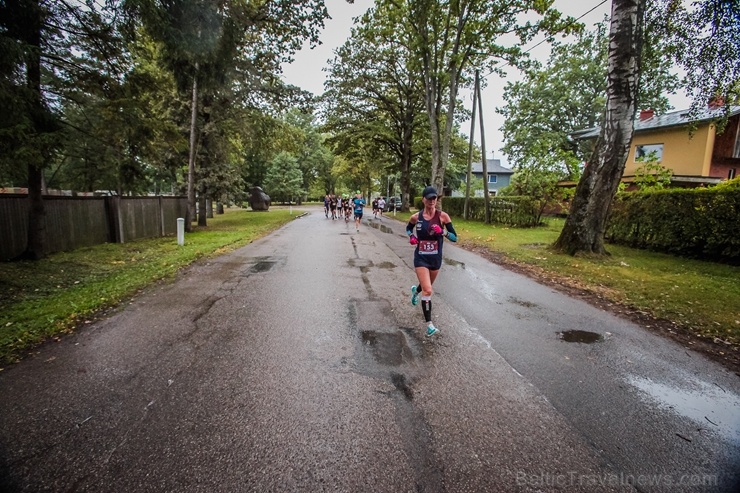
(627, 376, 740, 442)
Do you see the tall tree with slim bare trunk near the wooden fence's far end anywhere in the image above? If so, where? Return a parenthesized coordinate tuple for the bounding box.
(125, 0, 328, 224)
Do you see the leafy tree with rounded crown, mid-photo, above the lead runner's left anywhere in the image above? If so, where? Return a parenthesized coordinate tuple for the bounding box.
(322, 9, 428, 210)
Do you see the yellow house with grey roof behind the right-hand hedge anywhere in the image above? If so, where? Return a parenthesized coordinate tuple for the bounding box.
(571, 106, 740, 187)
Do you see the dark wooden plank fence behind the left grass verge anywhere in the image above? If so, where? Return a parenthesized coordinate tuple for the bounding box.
(0, 194, 188, 261)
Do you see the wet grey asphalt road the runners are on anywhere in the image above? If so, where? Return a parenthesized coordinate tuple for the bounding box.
(0, 208, 740, 493)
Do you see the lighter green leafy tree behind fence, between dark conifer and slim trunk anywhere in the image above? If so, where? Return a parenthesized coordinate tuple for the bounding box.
(52, 36, 187, 195)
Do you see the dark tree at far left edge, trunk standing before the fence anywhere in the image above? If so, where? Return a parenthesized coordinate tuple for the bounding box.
(0, 0, 121, 259)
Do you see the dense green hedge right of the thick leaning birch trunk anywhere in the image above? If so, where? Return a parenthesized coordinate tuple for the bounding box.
(606, 188, 740, 263)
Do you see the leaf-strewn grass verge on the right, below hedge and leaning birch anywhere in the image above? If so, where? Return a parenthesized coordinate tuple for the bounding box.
(397, 210, 740, 351)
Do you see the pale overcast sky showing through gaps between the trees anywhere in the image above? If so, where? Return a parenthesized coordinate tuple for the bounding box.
(283, 0, 690, 166)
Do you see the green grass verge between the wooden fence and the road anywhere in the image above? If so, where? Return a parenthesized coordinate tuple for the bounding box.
(0, 207, 296, 363)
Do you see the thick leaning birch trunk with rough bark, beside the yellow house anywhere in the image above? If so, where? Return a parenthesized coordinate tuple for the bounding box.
(554, 0, 645, 255)
